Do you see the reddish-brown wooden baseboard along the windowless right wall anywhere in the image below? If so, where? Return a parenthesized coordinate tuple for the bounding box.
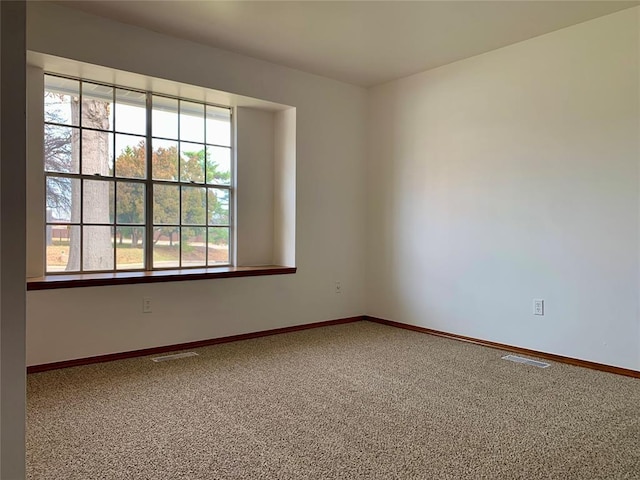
(364, 315, 640, 378)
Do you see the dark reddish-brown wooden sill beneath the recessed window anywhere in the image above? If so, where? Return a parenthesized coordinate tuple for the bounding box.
(27, 265, 296, 290)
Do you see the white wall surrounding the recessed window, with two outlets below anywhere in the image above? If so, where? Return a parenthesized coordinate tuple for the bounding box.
(27, 2, 366, 365)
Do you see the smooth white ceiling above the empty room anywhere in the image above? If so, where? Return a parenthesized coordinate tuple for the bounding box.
(58, 0, 639, 87)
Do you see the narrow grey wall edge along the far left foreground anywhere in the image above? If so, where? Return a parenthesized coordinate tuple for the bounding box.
(0, 2, 26, 480)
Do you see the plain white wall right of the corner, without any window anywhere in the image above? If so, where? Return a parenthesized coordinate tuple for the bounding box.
(367, 8, 640, 369)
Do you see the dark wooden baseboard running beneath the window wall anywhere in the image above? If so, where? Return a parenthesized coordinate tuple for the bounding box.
(27, 316, 364, 373)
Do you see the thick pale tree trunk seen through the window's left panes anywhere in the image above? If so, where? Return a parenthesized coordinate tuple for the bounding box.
(67, 100, 114, 271)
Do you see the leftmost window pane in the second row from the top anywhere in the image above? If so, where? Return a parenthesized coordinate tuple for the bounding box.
(44, 124, 80, 173)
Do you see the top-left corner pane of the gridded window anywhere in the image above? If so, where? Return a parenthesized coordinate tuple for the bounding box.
(44, 75, 80, 126)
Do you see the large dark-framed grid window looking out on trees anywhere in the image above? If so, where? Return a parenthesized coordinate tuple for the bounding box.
(44, 74, 234, 274)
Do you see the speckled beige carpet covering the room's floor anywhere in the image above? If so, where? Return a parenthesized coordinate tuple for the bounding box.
(27, 322, 640, 480)
